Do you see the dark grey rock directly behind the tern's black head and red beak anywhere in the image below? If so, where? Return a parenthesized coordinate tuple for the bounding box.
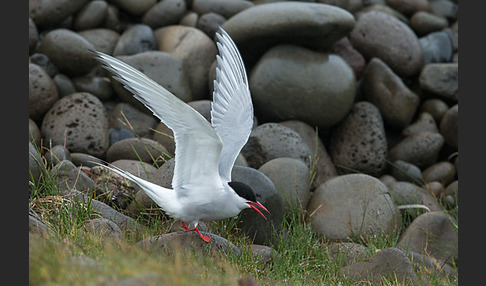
(231, 166, 284, 246)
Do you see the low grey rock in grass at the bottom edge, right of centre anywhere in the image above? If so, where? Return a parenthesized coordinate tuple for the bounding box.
(338, 247, 419, 285)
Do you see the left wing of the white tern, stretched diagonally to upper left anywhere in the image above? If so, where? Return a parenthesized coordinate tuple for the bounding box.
(93, 51, 222, 196)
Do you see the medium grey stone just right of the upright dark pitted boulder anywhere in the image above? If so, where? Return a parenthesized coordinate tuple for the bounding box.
(388, 131, 444, 169)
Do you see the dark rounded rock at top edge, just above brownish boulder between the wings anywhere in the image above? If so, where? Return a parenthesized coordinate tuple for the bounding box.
(142, 0, 187, 29)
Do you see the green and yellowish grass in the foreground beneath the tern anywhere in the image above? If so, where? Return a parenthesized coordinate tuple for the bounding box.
(29, 145, 458, 285)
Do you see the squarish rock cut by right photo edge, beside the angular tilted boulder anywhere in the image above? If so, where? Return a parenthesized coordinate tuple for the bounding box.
(419, 63, 459, 102)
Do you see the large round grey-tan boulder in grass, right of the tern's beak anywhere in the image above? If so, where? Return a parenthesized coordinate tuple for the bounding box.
(307, 174, 401, 241)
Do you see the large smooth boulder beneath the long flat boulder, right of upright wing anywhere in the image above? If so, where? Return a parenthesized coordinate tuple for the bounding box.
(249, 45, 356, 129)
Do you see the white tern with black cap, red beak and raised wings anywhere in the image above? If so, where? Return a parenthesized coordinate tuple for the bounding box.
(92, 29, 269, 242)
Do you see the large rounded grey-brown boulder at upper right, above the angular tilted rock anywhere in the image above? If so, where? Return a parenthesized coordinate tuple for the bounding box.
(349, 11, 424, 77)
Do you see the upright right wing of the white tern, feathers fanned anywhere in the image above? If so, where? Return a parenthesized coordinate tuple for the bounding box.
(211, 28, 253, 182)
